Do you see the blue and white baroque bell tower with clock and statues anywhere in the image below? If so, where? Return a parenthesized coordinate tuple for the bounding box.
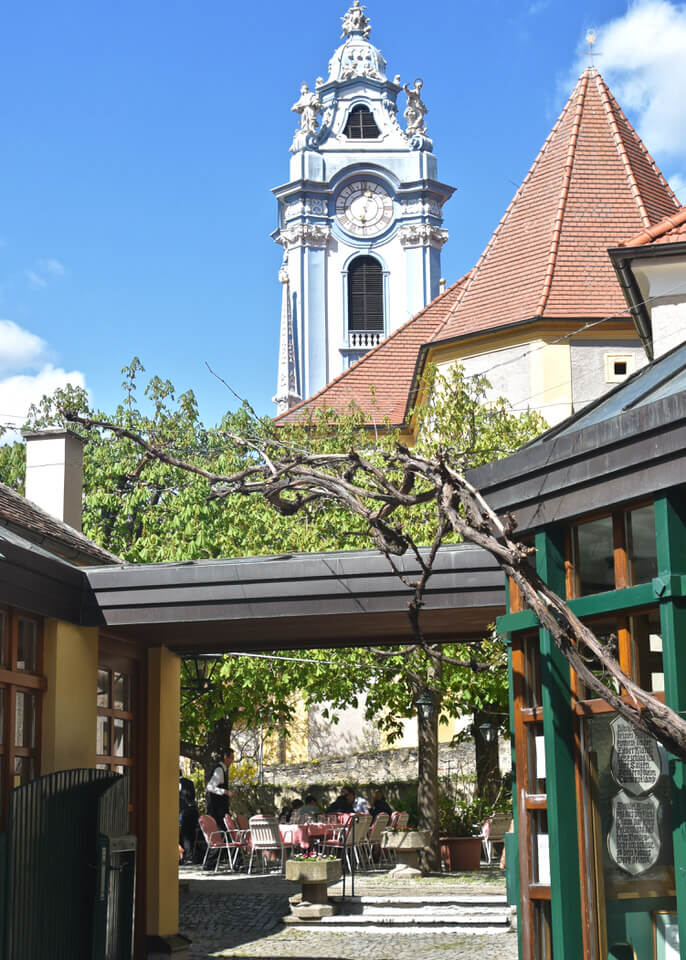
(272, 0, 453, 413)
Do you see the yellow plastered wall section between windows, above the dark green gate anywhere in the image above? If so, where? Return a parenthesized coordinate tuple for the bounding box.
(41, 620, 98, 774)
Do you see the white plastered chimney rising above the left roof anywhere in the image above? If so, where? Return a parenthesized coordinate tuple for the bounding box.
(24, 429, 83, 531)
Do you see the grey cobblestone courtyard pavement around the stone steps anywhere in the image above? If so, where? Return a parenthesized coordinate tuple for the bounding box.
(180, 868, 517, 960)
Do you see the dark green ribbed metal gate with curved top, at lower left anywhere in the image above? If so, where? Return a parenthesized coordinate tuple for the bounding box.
(0, 770, 136, 960)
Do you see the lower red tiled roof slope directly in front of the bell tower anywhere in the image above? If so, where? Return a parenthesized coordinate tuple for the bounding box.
(275, 274, 469, 425)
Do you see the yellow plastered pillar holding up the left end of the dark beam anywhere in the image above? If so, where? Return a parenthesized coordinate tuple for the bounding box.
(146, 647, 181, 937)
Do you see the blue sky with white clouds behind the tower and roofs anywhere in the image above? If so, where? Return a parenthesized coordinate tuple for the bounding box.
(0, 0, 686, 432)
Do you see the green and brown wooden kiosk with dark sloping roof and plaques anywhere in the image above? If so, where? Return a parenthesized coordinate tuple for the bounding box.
(469, 346, 686, 960)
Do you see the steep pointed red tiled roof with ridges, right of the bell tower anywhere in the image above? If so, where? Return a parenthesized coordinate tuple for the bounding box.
(433, 67, 679, 341)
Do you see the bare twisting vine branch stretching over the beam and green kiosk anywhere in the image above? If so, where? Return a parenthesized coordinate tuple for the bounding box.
(62, 410, 686, 760)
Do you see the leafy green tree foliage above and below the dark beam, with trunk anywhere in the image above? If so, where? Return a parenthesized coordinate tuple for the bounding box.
(17, 359, 544, 864)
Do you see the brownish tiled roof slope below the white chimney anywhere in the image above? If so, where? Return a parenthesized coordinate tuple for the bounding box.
(0, 483, 121, 566)
